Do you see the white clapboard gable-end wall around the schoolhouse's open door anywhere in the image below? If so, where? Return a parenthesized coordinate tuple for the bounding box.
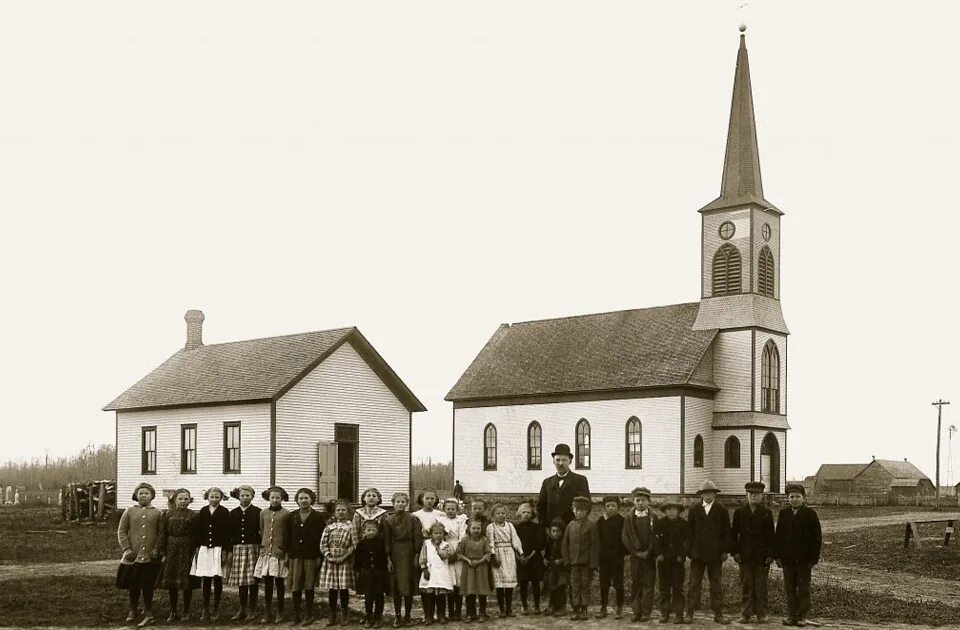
(277, 344, 410, 501)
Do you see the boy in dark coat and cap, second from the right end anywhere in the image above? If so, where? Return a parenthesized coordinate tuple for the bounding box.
(730, 481, 773, 623)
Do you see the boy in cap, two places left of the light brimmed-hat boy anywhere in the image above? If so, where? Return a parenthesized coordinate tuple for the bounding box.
(623, 488, 657, 622)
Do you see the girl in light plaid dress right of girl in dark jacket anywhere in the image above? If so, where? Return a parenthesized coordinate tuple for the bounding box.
(319, 499, 356, 626)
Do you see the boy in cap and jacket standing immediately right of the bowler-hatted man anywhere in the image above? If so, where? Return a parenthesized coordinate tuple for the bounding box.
(563, 497, 600, 621)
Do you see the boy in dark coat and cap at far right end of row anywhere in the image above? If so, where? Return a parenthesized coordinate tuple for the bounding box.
(774, 484, 823, 627)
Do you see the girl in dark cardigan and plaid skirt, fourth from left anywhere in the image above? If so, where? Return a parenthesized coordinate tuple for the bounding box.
(227, 486, 260, 622)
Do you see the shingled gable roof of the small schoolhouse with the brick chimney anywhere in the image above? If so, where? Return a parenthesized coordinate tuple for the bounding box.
(103, 327, 426, 412)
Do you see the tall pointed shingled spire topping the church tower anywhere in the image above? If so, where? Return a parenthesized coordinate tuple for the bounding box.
(701, 25, 779, 213)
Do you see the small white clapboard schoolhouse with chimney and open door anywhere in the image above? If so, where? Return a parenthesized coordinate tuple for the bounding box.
(104, 310, 426, 505)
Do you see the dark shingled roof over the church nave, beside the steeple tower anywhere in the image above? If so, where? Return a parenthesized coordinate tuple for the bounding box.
(446, 302, 717, 401)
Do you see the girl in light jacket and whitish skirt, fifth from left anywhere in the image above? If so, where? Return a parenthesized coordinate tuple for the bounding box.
(253, 486, 290, 623)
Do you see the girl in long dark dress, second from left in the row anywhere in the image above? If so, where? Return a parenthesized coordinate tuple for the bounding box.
(160, 488, 197, 623)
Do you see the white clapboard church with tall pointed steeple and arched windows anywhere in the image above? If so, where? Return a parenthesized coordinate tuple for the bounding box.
(446, 34, 790, 495)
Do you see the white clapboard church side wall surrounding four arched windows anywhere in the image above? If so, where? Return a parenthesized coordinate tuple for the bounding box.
(454, 397, 680, 494)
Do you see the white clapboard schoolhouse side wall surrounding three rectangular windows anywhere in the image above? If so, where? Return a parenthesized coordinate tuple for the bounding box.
(117, 403, 270, 507)
